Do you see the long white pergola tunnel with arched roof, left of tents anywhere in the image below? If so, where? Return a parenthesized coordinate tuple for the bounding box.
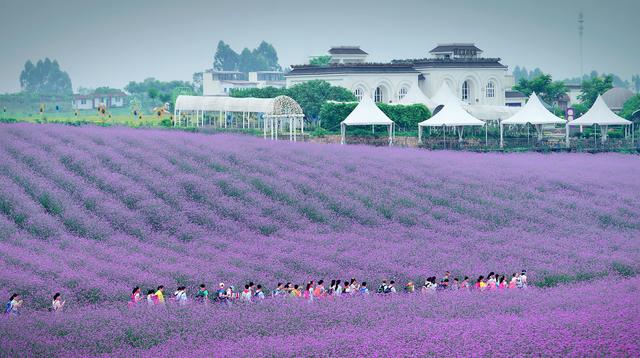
(173, 96, 304, 141)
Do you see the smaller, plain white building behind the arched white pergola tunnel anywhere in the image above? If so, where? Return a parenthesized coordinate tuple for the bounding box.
(202, 70, 285, 96)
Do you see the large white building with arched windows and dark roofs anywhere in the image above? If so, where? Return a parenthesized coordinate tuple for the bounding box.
(285, 43, 525, 106)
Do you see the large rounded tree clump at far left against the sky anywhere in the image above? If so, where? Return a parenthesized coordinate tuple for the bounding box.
(20, 57, 73, 95)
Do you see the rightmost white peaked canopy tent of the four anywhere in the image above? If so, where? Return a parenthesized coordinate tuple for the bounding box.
(565, 95, 634, 147)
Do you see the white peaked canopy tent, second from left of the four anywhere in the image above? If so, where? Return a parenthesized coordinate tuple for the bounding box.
(418, 98, 487, 143)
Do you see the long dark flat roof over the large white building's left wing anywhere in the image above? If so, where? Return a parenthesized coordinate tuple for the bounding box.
(285, 63, 419, 76)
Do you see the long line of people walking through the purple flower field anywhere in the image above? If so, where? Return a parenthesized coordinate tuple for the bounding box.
(5, 270, 527, 315)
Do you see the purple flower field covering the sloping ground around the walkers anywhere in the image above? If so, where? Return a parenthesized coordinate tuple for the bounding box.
(0, 124, 640, 356)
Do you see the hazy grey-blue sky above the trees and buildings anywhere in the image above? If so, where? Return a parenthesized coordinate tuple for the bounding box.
(0, 0, 640, 92)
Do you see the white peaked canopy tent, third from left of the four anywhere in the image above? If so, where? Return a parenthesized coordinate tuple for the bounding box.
(500, 92, 567, 148)
